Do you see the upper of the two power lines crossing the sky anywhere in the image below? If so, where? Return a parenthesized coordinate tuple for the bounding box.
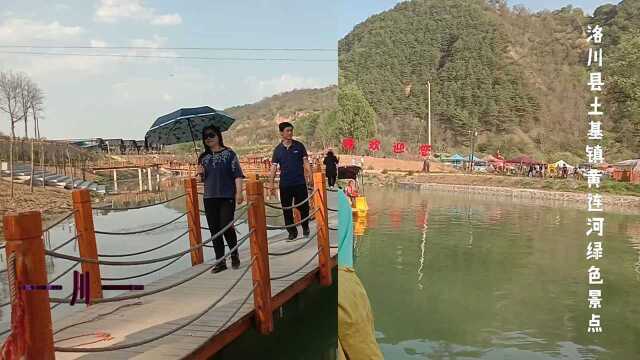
(0, 44, 338, 52)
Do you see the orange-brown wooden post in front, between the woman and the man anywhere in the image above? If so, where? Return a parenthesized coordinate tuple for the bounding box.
(247, 179, 273, 335)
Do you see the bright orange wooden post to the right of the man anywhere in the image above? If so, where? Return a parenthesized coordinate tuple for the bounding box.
(313, 171, 331, 286)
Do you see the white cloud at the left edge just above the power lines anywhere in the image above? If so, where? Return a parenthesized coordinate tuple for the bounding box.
(0, 18, 84, 43)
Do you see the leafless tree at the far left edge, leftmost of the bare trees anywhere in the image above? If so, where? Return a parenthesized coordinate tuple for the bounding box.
(0, 72, 24, 198)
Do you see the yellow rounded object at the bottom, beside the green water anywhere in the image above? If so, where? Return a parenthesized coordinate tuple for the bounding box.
(338, 268, 383, 360)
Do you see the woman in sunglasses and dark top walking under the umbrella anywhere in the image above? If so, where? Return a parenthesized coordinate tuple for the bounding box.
(198, 126, 244, 274)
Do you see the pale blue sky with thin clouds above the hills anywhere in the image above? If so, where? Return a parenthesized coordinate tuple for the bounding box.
(0, 0, 620, 139)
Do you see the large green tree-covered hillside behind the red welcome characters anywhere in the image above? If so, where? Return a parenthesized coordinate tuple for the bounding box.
(339, 0, 640, 159)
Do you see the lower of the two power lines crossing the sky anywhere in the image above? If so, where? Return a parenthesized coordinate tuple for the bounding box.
(0, 51, 337, 62)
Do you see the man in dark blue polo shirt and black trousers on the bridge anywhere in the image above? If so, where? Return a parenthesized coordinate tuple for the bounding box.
(271, 122, 311, 241)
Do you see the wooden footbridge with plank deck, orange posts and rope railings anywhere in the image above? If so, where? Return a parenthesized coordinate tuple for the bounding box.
(3, 169, 337, 359)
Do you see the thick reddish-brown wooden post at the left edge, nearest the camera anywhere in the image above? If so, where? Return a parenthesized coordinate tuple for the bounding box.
(3, 211, 55, 360)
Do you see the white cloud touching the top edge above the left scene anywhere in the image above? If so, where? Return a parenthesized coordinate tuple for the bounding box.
(95, 0, 182, 25)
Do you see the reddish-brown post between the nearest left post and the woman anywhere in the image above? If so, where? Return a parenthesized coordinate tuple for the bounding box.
(71, 189, 102, 305)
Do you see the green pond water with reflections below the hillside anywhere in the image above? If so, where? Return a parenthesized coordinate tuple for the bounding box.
(354, 188, 640, 360)
